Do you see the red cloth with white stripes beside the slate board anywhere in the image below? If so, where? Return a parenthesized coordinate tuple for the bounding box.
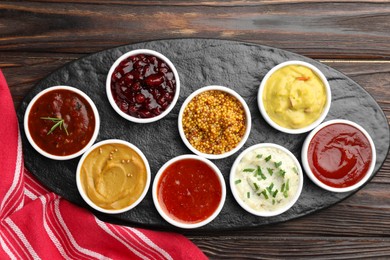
(0, 71, 206, 259)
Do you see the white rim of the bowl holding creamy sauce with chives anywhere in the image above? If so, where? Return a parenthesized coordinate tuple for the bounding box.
(229, 143, 304, 217)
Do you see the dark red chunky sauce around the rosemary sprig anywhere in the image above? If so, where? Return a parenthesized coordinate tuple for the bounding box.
(28, 89, 95, 156)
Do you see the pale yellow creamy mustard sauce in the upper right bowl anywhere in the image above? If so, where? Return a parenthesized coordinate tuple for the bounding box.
(262, 65, 327, 129)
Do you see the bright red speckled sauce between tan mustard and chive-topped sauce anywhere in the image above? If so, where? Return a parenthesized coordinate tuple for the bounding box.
(157, 159, 222, 223)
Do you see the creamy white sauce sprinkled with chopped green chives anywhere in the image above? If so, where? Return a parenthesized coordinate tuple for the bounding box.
(234, 147, 300, 212)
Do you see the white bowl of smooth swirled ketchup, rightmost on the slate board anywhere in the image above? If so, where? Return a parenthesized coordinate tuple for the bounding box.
(301, 119, 376, 192)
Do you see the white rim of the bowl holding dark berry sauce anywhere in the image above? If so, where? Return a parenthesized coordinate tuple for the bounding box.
(106, 49, 180, 123)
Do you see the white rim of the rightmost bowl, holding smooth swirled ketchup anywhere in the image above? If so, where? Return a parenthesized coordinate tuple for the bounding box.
(301, 119, 376, 192)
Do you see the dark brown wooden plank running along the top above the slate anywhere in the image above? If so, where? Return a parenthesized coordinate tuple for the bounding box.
(0, 0, 390, 59)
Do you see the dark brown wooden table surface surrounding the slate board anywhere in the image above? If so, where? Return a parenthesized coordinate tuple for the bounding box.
(0, 0, 390, 259)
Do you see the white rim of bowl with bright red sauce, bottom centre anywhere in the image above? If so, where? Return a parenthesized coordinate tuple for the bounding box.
(152, 154, 226, 229)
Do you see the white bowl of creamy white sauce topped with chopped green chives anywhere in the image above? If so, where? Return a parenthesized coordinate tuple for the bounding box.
(230, 143, 303, 217)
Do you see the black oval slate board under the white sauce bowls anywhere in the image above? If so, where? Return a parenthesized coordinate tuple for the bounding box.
(18, 39, 389, 230)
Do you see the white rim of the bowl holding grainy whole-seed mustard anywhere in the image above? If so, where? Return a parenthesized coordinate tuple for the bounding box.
(178, 85, 252, 159)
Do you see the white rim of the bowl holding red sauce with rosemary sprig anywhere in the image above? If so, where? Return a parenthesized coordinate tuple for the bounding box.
(24, 86, 100, 160)
